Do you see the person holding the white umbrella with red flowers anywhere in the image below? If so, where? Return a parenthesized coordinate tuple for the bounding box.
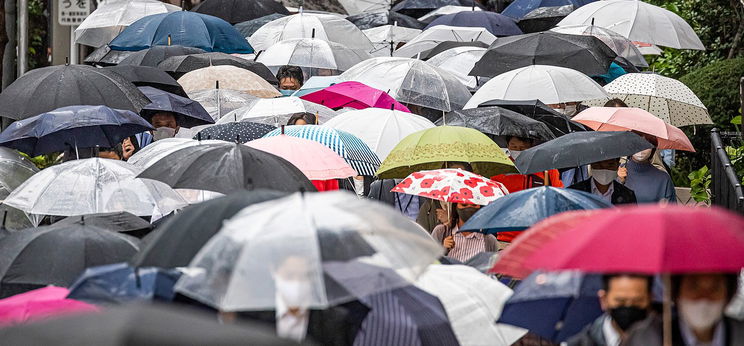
(431, 203, 499, 263)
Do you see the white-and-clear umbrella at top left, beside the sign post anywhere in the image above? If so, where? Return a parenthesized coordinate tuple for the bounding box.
(75, 0, 181, 48)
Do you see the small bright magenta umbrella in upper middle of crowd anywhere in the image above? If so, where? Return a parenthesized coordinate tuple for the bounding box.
(300, 81, 411, 113)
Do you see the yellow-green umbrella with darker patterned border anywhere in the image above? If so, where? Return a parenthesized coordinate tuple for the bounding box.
(377, 126, 516, 179)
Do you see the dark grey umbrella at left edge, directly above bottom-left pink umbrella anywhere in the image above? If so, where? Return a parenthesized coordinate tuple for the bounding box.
(0, 225, 138, 297)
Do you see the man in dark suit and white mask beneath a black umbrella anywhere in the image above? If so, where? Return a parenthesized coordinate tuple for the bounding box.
(568, 158, 636, 204)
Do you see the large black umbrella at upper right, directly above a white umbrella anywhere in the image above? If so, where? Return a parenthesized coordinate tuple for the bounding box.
(470, 31, 617, 77)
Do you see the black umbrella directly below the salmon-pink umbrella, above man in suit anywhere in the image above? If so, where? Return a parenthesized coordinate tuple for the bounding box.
(514, 131, 654, 174)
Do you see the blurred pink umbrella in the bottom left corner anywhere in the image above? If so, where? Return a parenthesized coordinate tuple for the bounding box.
(0, 286, 99, 325)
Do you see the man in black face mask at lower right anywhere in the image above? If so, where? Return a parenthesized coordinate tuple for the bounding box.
(567, 274, 653, 346)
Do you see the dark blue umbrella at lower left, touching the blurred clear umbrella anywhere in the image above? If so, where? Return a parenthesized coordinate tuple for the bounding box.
(67, 263, 181, 304)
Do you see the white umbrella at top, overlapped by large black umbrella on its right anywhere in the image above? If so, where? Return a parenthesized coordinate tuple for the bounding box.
(393, 25, 496, 58)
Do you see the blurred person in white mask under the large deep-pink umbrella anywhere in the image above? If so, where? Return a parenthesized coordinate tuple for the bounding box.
(624, 273, 744, 346)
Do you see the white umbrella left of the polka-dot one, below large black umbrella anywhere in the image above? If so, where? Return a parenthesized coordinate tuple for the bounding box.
(465, 65, 607, 108)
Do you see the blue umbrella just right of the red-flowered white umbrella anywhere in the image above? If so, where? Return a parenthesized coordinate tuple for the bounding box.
(460, 186, 612, 233)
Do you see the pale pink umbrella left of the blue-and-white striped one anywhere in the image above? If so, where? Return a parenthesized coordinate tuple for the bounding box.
(245, 134, 358, 180)
